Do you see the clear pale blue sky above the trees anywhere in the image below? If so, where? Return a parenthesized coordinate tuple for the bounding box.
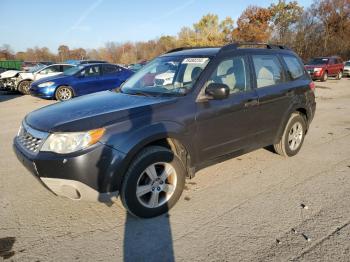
(0, 0, 312, 51)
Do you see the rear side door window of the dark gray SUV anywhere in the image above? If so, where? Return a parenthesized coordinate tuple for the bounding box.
(252, 55, 284, 88)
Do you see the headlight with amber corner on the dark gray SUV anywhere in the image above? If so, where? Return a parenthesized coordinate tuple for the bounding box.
(41, 128, 105, 154)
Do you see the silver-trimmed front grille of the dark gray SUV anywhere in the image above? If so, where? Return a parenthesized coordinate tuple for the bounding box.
(17, 123, 48, 153)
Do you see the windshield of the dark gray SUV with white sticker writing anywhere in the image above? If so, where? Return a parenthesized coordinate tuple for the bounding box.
(121, 56, 209, 95)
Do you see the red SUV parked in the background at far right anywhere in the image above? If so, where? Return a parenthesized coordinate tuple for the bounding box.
(305, 56, 344, 82)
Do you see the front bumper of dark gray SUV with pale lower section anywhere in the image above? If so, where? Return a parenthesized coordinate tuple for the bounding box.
(13, 138, 124, 202)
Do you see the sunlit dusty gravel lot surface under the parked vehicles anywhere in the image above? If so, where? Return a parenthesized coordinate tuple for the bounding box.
(0, 79, 350, 261)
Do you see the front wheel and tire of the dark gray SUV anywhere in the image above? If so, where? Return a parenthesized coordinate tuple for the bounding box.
(120, 146, 186, 218)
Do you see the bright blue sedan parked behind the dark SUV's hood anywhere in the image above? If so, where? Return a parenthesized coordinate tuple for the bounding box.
(29, 63, 133, 101)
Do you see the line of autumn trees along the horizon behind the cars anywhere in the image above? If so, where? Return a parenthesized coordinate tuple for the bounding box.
(0, 0, 350, 64)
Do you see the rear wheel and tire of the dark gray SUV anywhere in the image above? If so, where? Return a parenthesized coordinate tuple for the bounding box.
(273, 113, 306, 157)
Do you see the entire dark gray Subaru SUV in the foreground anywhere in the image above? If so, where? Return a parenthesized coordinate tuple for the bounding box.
(14, 43, 316, 217)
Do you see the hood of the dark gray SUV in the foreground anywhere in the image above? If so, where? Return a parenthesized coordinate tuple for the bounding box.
(25, 91, 177, 132)
